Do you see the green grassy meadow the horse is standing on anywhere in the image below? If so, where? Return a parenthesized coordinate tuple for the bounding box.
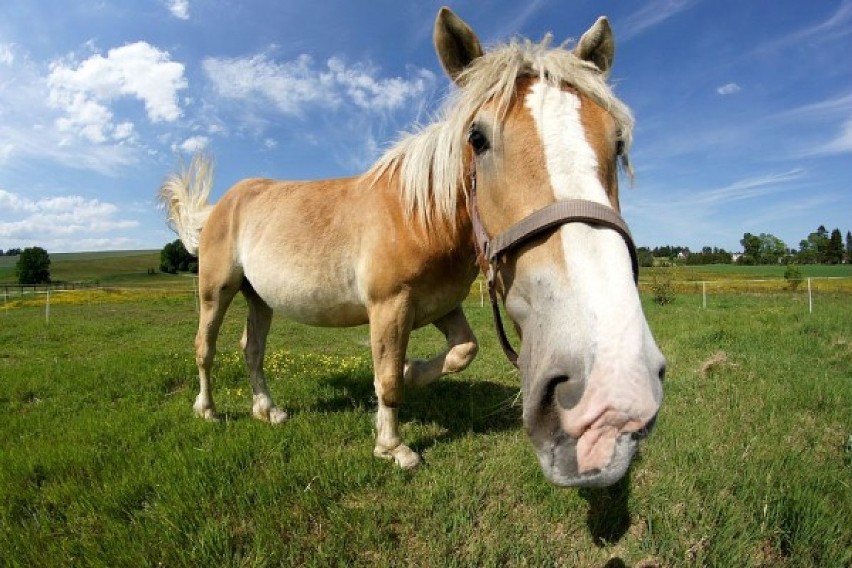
(0, 254, 852, 568)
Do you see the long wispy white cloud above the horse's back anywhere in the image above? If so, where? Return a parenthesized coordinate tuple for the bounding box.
(203, 54, 435, 115)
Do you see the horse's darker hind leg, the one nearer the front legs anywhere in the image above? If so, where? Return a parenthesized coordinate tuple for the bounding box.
(240, 282, 287, 424)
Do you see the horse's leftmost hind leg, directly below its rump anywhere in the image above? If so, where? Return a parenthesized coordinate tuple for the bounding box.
(192, 274, 239, 421)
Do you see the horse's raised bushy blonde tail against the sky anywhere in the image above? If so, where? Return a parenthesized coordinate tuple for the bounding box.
(159, 152, 213, 254)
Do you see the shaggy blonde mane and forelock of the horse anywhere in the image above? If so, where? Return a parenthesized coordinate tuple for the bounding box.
(367, 35, 633, 227)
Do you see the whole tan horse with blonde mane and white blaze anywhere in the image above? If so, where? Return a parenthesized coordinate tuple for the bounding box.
(160, 8, 666, 486)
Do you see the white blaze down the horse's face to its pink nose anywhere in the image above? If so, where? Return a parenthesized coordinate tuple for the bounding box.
(526, 82, 657, 472)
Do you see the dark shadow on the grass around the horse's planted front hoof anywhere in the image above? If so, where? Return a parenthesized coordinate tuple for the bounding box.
(312, 371, 521, 451)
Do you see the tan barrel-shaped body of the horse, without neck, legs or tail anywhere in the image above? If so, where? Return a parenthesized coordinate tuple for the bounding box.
(199, 173, 475, 326)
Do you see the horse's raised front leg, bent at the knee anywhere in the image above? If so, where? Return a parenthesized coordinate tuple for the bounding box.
(403, 306, 479, 386)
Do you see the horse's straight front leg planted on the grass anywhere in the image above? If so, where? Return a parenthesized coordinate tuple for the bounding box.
(370, 298, 420, 469)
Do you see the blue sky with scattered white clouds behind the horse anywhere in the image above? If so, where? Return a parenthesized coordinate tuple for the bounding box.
(0, 0, 852, 252)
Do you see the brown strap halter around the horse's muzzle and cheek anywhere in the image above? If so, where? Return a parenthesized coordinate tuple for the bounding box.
(470, 159, 639, 368)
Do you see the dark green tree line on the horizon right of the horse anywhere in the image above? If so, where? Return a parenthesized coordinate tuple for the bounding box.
(637, 225, 852, 266)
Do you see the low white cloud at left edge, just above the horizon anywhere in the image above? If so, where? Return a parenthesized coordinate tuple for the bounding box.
(0, 189, 139, 242)
